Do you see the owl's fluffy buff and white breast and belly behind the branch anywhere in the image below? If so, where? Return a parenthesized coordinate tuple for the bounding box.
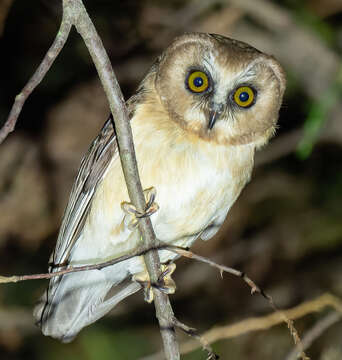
(82, 103, 254, 264)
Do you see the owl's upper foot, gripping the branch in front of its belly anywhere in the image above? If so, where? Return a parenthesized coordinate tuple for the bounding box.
(121, 187, 159, 230)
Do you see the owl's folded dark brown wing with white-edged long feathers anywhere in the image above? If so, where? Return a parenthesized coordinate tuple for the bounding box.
(51, 115, 118, 266)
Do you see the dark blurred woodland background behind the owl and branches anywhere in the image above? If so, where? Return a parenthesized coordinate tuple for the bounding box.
(0, 0, 342, 360)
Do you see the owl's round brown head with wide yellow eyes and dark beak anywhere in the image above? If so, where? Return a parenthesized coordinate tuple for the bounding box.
(155, 33, 285, 146)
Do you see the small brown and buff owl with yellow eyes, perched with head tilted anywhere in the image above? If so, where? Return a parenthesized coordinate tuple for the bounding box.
(34, 33, 285, 342)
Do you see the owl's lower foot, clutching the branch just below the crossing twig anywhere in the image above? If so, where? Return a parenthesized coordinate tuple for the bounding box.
(132, 263, 176, 303)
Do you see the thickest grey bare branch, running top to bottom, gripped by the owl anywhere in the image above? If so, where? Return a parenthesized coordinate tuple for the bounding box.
(63, 0, 180, 360)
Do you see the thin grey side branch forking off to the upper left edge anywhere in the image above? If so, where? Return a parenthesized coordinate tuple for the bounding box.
(0, 5, 72, 144)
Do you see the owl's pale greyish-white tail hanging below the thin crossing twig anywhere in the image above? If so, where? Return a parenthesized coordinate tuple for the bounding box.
(33, 262, 141, 342)
